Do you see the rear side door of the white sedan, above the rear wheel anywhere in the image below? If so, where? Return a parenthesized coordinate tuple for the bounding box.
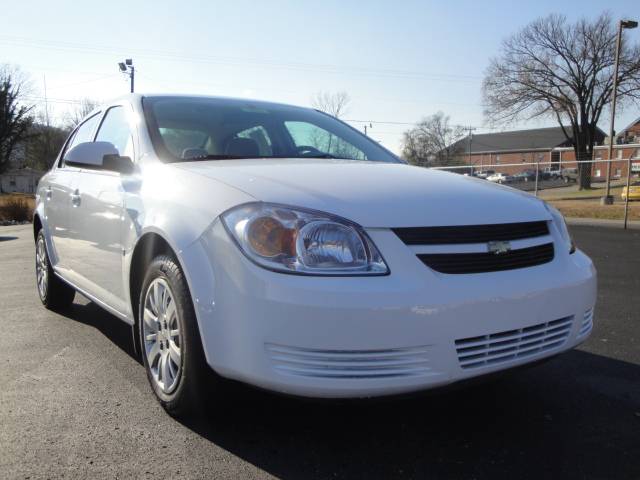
(44, 114, 100, 274)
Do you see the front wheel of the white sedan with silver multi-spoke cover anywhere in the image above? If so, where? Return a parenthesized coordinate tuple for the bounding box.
(138, 255, 216, 417)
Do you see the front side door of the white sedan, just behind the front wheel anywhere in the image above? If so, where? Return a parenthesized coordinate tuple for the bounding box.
(66, 105, 135, 313)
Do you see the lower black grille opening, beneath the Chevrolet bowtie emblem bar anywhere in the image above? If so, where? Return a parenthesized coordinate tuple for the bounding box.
(418, 243, 554, 274)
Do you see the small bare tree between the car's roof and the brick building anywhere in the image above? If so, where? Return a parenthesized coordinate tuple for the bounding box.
(402, 112, 464, 166)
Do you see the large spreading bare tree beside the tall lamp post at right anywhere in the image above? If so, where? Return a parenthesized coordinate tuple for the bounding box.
(483, 13, 640, 189)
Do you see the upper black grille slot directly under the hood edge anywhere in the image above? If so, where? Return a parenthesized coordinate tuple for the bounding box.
(393, 221, 549, 245)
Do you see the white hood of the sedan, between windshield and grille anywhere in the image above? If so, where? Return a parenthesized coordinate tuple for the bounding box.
(174, 159, 550, 228)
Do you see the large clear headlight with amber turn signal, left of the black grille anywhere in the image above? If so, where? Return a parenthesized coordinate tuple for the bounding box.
(221, 203, 389, 275)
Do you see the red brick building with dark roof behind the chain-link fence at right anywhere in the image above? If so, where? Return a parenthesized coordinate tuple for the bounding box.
(457, 118, 640, 181)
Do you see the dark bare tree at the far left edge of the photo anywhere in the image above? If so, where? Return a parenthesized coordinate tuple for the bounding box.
(0, 65, 33, 173)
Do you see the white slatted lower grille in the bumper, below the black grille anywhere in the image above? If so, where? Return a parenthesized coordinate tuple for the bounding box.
(456, 316, 573, 369)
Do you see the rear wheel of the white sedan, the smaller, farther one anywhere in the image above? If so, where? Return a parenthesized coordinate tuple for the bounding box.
(36, 229, 76, 310)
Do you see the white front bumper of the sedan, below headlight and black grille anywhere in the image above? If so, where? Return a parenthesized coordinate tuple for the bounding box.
(181, 221, 596, 398)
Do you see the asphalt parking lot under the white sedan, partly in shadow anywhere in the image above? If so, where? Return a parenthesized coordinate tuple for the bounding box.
(0, 226, 640, 479)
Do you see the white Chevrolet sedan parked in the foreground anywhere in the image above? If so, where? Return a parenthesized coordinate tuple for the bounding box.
(34, 95, 596, 415)
